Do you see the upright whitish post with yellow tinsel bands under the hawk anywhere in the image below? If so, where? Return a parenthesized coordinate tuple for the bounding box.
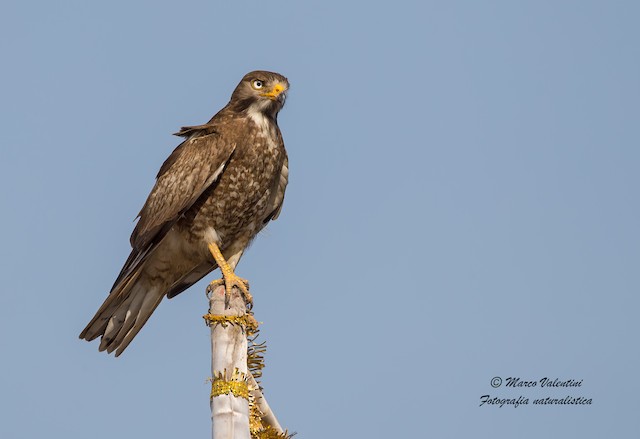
(207, 286, 251, 439)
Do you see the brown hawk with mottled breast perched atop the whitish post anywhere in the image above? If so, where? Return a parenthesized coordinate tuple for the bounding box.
(80, 71, 289, 356)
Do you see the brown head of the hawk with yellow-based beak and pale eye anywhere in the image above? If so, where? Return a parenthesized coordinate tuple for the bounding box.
(229, 70, 289, 118)
